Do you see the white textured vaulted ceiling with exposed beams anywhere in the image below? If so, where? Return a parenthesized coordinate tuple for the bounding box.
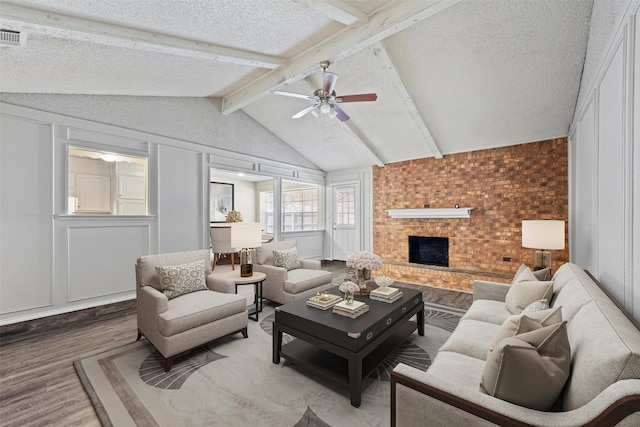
(0, 0, 593, 171)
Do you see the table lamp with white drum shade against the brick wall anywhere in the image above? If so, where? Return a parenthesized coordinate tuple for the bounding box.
(522, 220, 564, 270)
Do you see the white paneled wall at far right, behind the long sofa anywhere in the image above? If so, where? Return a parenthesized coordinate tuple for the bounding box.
(570, 0, 640, 319)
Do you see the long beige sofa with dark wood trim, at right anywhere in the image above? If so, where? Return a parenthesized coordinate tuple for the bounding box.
(391, 263, 640, 427)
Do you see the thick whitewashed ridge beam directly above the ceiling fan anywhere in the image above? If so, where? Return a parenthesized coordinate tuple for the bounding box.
(222, 0, 461, 114)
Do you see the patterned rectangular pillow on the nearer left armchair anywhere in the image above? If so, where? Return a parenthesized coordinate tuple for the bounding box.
(156, 259, 208, 299)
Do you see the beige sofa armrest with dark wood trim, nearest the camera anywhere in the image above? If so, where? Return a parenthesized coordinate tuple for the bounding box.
(391, 363, 640, 427)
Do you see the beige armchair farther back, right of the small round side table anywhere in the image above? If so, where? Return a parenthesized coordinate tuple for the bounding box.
(253, 240, 333, 304)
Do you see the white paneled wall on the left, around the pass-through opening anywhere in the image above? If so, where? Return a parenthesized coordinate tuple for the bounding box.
(0, 104, 324, 325)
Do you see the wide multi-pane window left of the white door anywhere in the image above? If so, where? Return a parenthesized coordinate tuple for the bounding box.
(282, 180, 321, 231)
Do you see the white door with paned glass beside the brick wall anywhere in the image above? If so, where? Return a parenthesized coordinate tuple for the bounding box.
(332, 183, 360, 261)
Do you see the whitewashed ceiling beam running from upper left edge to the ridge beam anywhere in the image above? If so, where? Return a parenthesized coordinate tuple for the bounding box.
(0, 3, 284, 69)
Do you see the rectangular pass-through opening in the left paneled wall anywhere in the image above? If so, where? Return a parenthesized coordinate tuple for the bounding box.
(67, 147, 148, 215)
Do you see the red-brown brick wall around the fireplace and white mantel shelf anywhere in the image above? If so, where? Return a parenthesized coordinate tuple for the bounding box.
(373, 138, 569, 292)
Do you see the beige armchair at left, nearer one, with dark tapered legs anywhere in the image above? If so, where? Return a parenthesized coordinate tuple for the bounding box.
(136, 249, 248, 371)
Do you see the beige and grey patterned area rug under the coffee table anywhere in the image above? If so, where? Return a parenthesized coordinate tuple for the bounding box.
(74, 304, 464, 427)
